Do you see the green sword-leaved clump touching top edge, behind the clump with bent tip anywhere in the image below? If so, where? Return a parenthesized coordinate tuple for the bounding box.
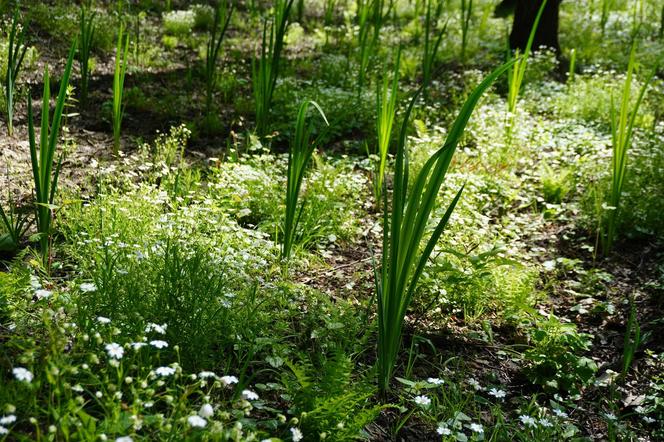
(251, 0, 294, 137)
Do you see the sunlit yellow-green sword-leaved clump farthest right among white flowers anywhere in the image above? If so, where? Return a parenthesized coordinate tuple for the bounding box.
(598, 42, 656, 255)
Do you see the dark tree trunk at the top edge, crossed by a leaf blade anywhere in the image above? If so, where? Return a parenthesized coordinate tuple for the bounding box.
(510, 0, 562, 53)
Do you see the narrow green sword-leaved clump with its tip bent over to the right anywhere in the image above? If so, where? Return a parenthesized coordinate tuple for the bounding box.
(281, 101, 329, 259)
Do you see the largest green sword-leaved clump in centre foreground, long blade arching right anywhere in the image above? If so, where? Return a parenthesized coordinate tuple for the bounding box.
(376, 61, 514, 394)
